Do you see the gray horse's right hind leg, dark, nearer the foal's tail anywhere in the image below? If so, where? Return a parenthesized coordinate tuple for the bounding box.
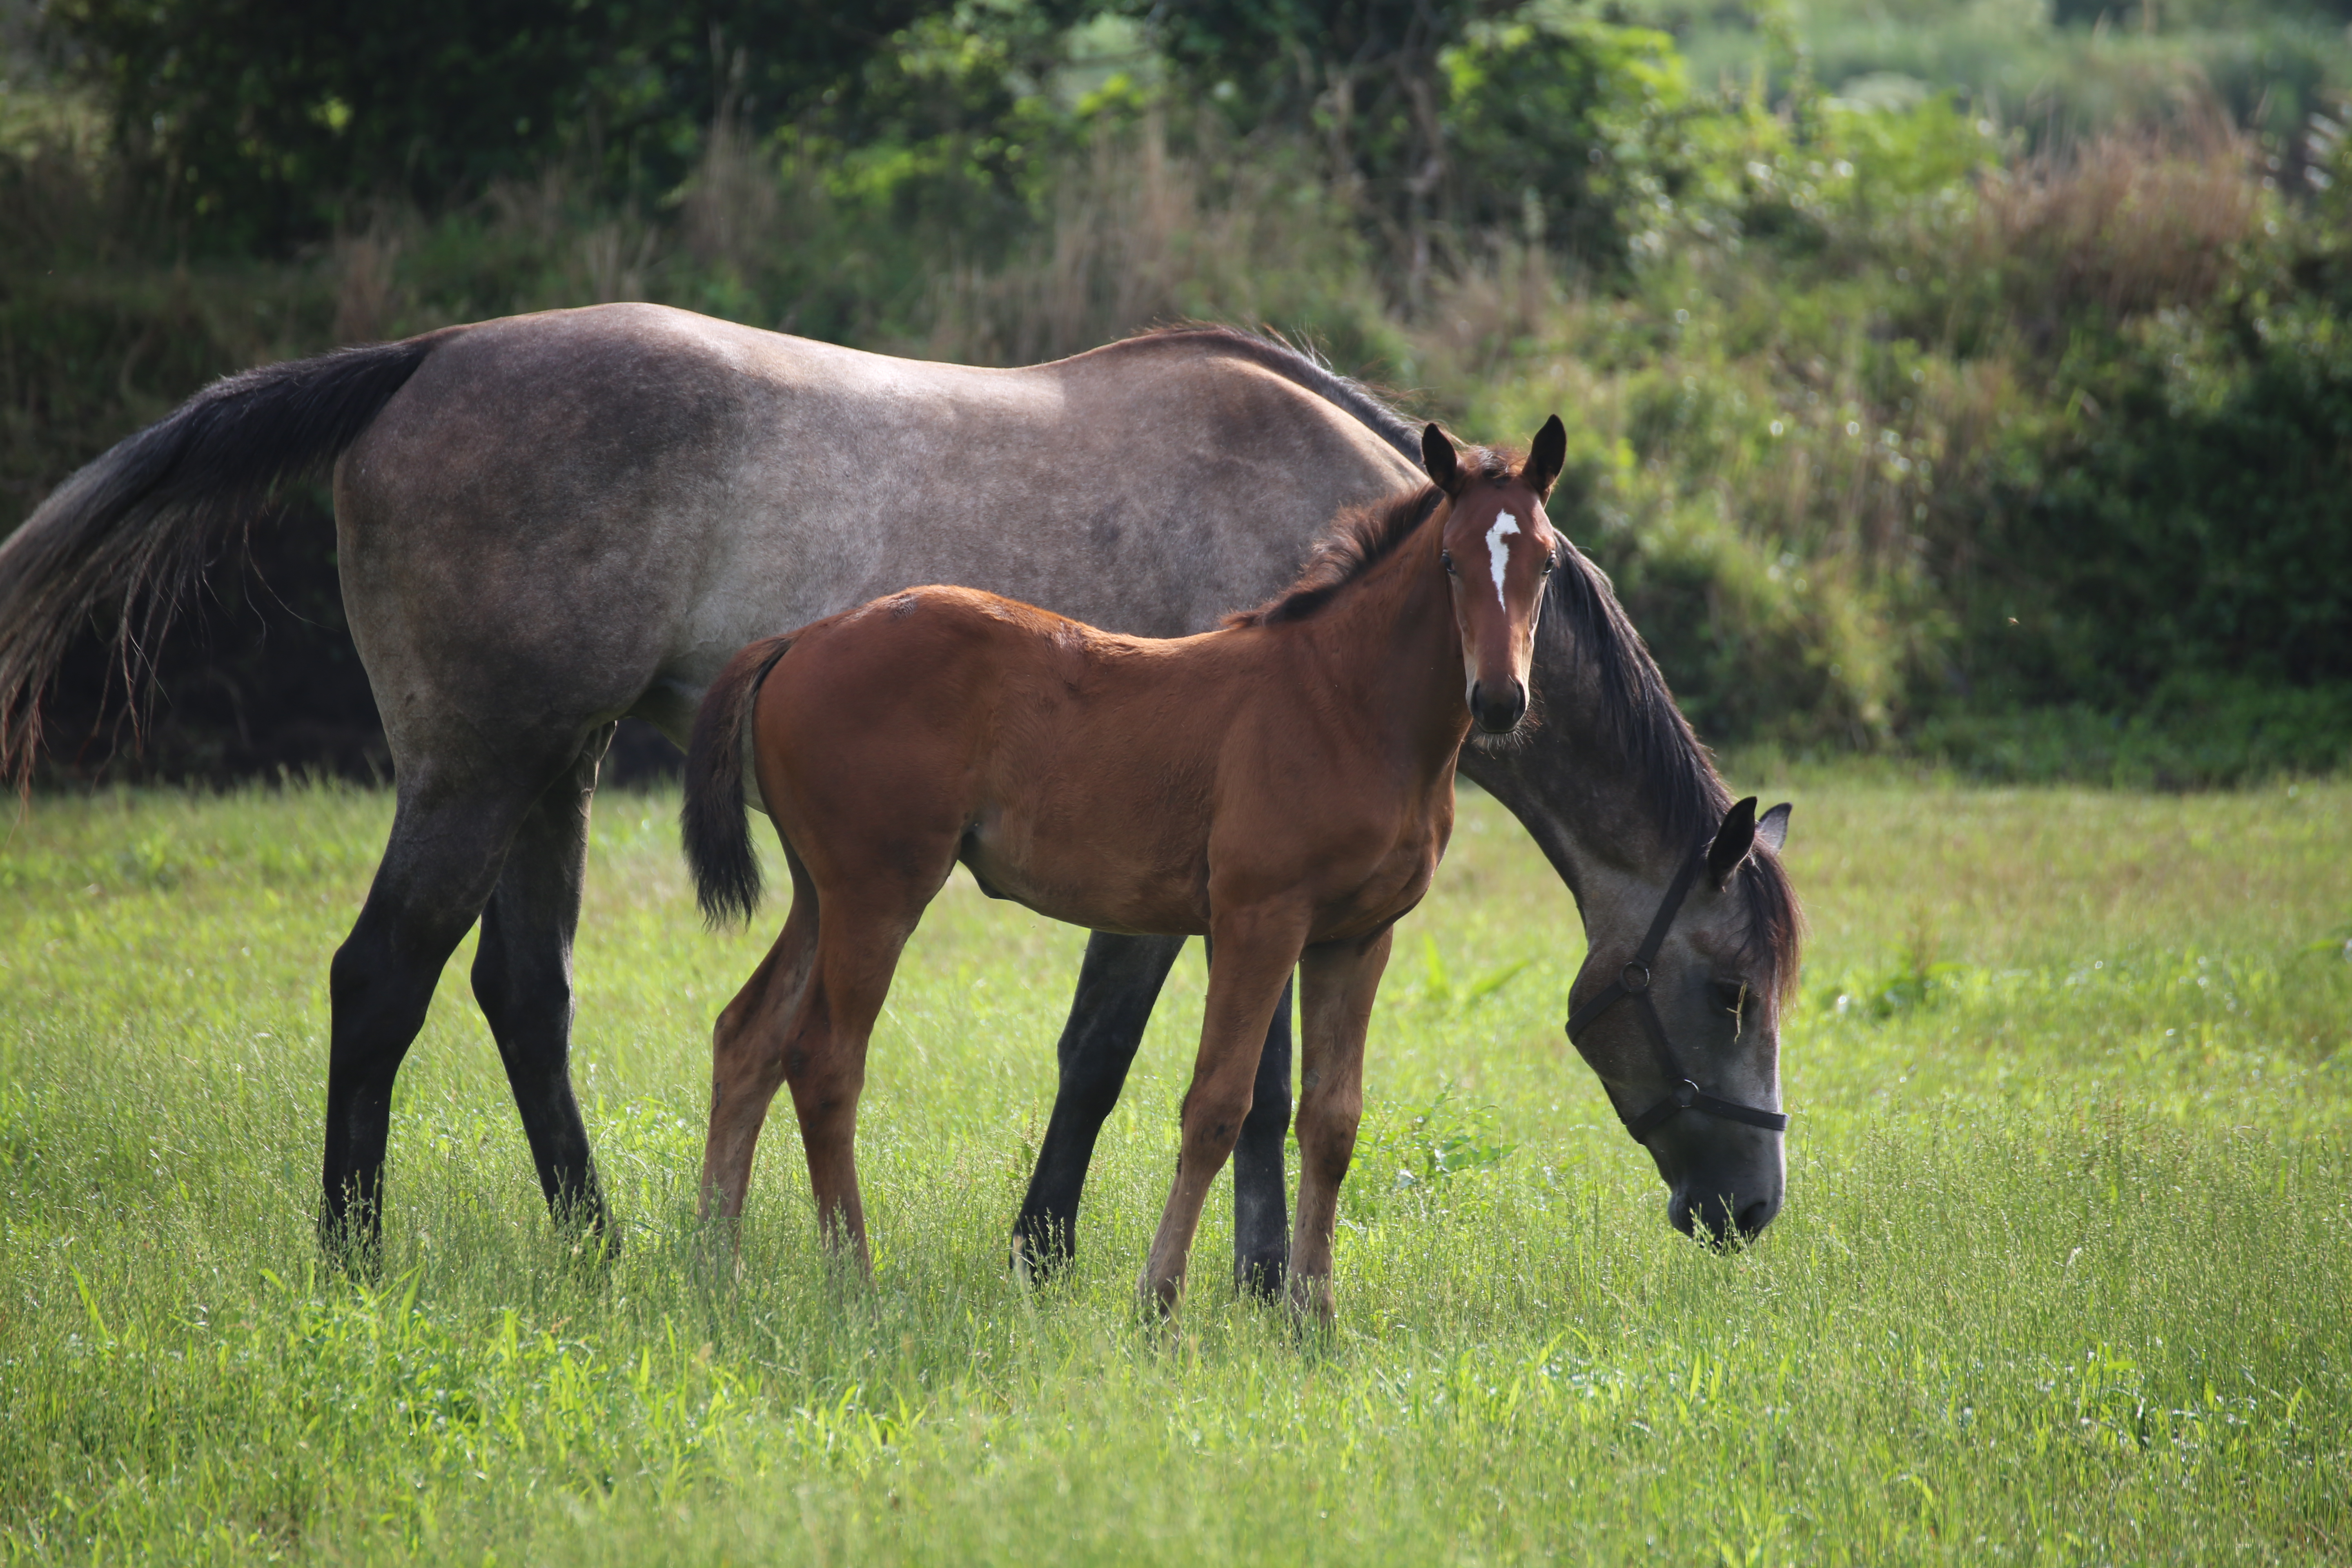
(473, 724, 614, 1244)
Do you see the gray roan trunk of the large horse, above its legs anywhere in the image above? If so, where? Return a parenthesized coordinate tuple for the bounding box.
(336, 305, 1411, 757)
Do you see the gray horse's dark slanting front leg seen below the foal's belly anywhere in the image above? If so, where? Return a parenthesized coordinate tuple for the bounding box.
(1014, 931, 1185, 1274)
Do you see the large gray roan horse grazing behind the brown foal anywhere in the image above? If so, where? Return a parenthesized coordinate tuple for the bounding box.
(0, 305, 1797, 1288)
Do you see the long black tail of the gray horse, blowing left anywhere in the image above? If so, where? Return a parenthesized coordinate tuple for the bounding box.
(0, 329, 461, 778)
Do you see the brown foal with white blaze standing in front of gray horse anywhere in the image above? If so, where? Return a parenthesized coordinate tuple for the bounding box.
(684, 419, 1566, 1316)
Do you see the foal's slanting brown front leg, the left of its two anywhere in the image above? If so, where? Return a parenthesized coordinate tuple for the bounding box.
(1138, 907, 1305, 1312)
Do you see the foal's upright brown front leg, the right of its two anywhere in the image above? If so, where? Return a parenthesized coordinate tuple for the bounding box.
(1291, 926, 1392, 1323)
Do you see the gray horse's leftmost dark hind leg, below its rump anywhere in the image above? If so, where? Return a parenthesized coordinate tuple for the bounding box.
(320, 776, 536, 1248)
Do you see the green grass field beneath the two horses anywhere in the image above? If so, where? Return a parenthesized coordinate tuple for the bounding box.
(0, 771, 2352, 1563)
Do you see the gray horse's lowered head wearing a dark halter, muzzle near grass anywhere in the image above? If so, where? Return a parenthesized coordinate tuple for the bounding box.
(1569, 797, 1797, 1244)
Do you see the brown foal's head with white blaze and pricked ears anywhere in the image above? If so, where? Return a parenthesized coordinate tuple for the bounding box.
(1421, 414, 1569, 736)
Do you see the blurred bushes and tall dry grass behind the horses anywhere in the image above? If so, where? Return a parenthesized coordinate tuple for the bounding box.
(0, 0, 2352, 788)
